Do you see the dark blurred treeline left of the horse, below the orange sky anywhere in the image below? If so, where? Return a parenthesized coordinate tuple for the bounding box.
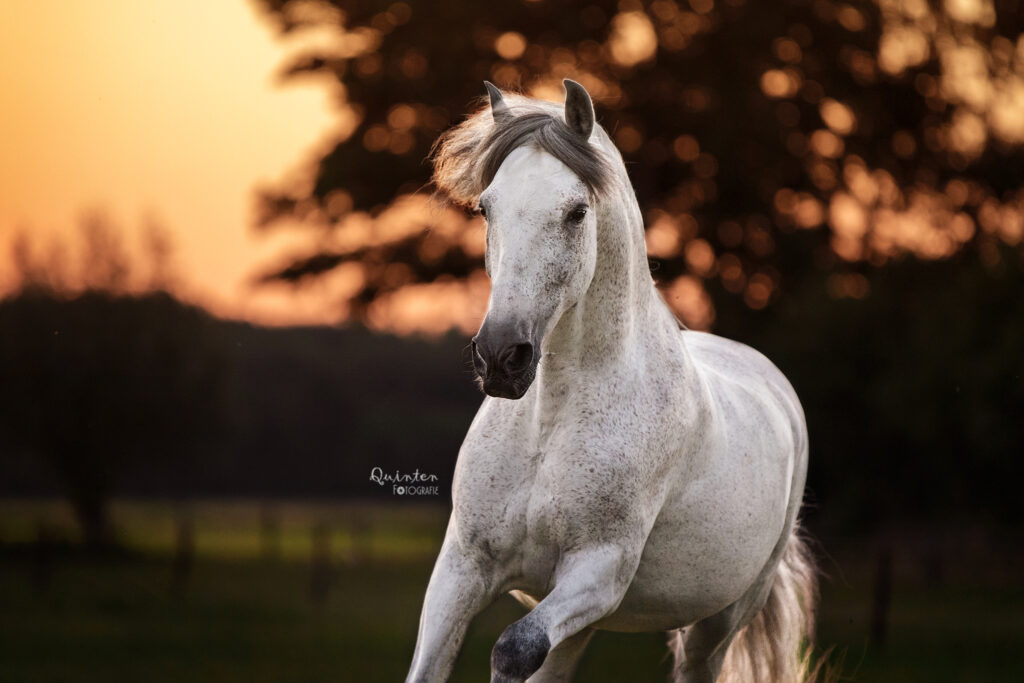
(0, 290, 478, 545)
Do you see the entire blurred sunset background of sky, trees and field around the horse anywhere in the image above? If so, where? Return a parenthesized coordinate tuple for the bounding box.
(0, 0, 1024, 682)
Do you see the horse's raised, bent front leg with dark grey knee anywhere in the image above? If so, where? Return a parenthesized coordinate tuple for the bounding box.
(490, 544, 641, 683)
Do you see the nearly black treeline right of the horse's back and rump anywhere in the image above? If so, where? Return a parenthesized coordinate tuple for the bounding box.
(716, 240, 1024, 532)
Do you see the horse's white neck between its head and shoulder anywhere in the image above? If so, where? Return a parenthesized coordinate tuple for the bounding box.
(540, 183, 676, 388)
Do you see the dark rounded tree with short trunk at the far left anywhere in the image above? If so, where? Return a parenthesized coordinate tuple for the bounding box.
(0, 218, 224, 548)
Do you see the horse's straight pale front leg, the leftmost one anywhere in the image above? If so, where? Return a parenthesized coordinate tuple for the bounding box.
(406, 530, 496, 683)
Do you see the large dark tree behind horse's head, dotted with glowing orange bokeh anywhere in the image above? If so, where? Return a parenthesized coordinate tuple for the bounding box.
(253, 0, 1024, 318)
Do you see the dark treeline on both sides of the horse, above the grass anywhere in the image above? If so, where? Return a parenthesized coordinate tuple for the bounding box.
(0, 240, 1024, 535)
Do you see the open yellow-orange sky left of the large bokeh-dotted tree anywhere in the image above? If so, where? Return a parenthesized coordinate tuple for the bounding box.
(0, 0, 337, 324)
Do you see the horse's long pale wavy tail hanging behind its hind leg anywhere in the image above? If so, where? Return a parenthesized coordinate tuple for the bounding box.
(672, 528, 817, 683)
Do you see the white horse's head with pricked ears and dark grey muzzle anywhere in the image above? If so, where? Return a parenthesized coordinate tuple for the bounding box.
(473, 80, 607, 398)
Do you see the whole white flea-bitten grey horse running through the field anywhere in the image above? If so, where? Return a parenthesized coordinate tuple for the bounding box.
(407, 80, 814, 683)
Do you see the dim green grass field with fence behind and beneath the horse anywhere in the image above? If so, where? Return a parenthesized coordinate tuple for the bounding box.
(0, 502, 1024, 683)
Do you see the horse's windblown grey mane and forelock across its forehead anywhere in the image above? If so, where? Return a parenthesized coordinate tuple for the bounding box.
(432, 93, 625, 206)
